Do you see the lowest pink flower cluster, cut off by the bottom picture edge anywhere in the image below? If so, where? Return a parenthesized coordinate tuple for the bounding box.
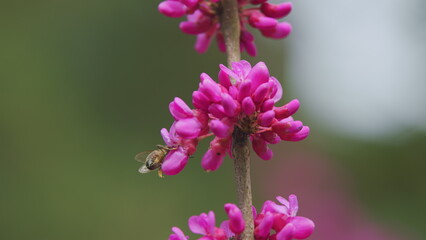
(169, 195, 315, 240)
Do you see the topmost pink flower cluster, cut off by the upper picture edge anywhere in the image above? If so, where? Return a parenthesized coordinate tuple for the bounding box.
(158, 0, 292, 56)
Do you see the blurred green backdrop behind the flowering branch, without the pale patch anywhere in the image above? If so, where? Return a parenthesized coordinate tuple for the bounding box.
(0, 0, 426, 240)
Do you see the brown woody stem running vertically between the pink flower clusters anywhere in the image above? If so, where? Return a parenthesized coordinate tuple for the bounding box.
(220, 0, 254, 240)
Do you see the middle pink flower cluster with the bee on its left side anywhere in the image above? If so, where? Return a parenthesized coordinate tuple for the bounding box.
(155, 60, 309, 175)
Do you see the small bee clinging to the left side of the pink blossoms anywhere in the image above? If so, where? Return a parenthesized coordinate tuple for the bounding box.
(135, 145, 176, 178)
